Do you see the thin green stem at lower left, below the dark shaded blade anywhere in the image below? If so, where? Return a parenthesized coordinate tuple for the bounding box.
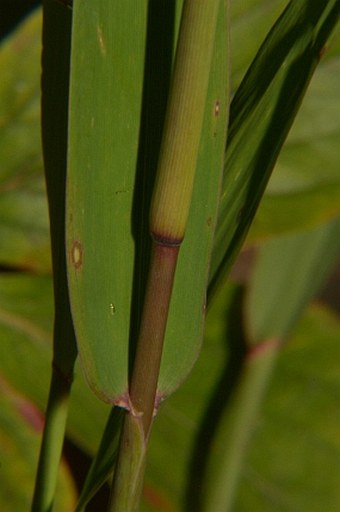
(31, 369, 71, 512)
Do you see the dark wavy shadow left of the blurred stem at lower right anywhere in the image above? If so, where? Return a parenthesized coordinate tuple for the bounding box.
(184, 287, 247, 512)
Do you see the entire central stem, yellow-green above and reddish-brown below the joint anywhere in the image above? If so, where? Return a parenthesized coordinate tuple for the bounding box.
(109, 0, 220, 512)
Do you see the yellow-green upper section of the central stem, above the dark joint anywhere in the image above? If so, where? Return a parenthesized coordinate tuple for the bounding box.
(150, 0, 220, 241)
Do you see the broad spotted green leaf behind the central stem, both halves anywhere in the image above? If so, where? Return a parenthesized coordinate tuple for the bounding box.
(67, 2, 228, 404)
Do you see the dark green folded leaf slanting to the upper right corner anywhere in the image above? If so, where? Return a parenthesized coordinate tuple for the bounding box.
(210, 0, 340, 291)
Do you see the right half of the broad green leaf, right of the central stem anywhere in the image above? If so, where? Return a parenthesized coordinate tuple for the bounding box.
(158, 2, 229, 396)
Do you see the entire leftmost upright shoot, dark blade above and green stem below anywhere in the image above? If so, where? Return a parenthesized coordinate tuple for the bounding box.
(32, 0, 77, 512)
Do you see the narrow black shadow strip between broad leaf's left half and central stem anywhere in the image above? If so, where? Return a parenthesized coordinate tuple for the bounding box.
(129, 0, 175, 373)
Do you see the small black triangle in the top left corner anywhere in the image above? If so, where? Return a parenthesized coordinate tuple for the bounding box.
(0, 0, 41, 40)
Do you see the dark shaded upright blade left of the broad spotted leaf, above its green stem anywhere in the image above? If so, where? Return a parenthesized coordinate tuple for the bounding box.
(41, 0, 77, 374)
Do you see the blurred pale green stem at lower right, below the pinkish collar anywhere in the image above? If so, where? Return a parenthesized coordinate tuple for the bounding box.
(202, 339, 281, 512)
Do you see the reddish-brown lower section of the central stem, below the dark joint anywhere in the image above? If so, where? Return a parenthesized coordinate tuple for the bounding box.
(109, 242, 179, 512)
